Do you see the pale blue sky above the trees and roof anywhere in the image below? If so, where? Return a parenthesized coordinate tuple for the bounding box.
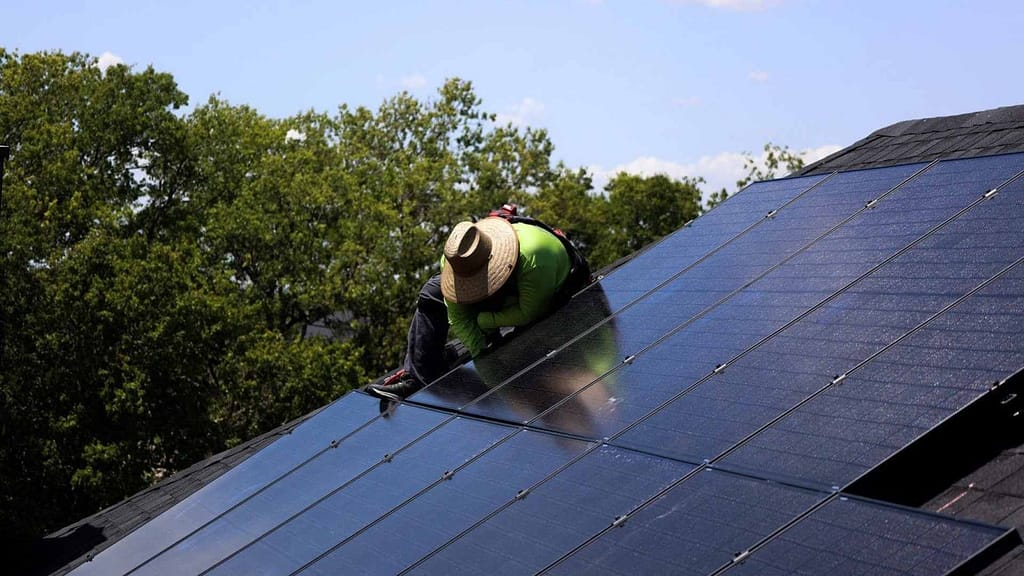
(6, 0, 1024, 190)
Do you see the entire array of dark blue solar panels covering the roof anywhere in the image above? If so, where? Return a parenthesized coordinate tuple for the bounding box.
(73, 155, 1024, 576)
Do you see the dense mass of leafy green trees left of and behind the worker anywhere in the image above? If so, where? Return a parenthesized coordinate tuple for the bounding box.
(0, 50, 716, 536)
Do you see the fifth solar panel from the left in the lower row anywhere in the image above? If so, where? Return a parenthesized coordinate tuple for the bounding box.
(403, 446, 692, 574)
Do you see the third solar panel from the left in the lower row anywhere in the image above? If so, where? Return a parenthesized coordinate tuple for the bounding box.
(208, 418, 514, 576)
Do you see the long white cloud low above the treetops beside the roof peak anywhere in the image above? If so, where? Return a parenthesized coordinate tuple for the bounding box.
(588, 145, 843, 202)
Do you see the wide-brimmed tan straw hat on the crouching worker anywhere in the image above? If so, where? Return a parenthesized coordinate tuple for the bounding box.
(441, 217, 519, 304)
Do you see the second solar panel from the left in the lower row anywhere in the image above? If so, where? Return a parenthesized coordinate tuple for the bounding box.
(133, 406, 449, 575)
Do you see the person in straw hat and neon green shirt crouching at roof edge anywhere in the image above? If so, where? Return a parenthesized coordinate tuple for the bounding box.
(366, 204, 591, 414)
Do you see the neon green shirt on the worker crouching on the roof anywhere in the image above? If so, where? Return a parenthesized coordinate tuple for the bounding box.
(441, 222, 571, 357)
